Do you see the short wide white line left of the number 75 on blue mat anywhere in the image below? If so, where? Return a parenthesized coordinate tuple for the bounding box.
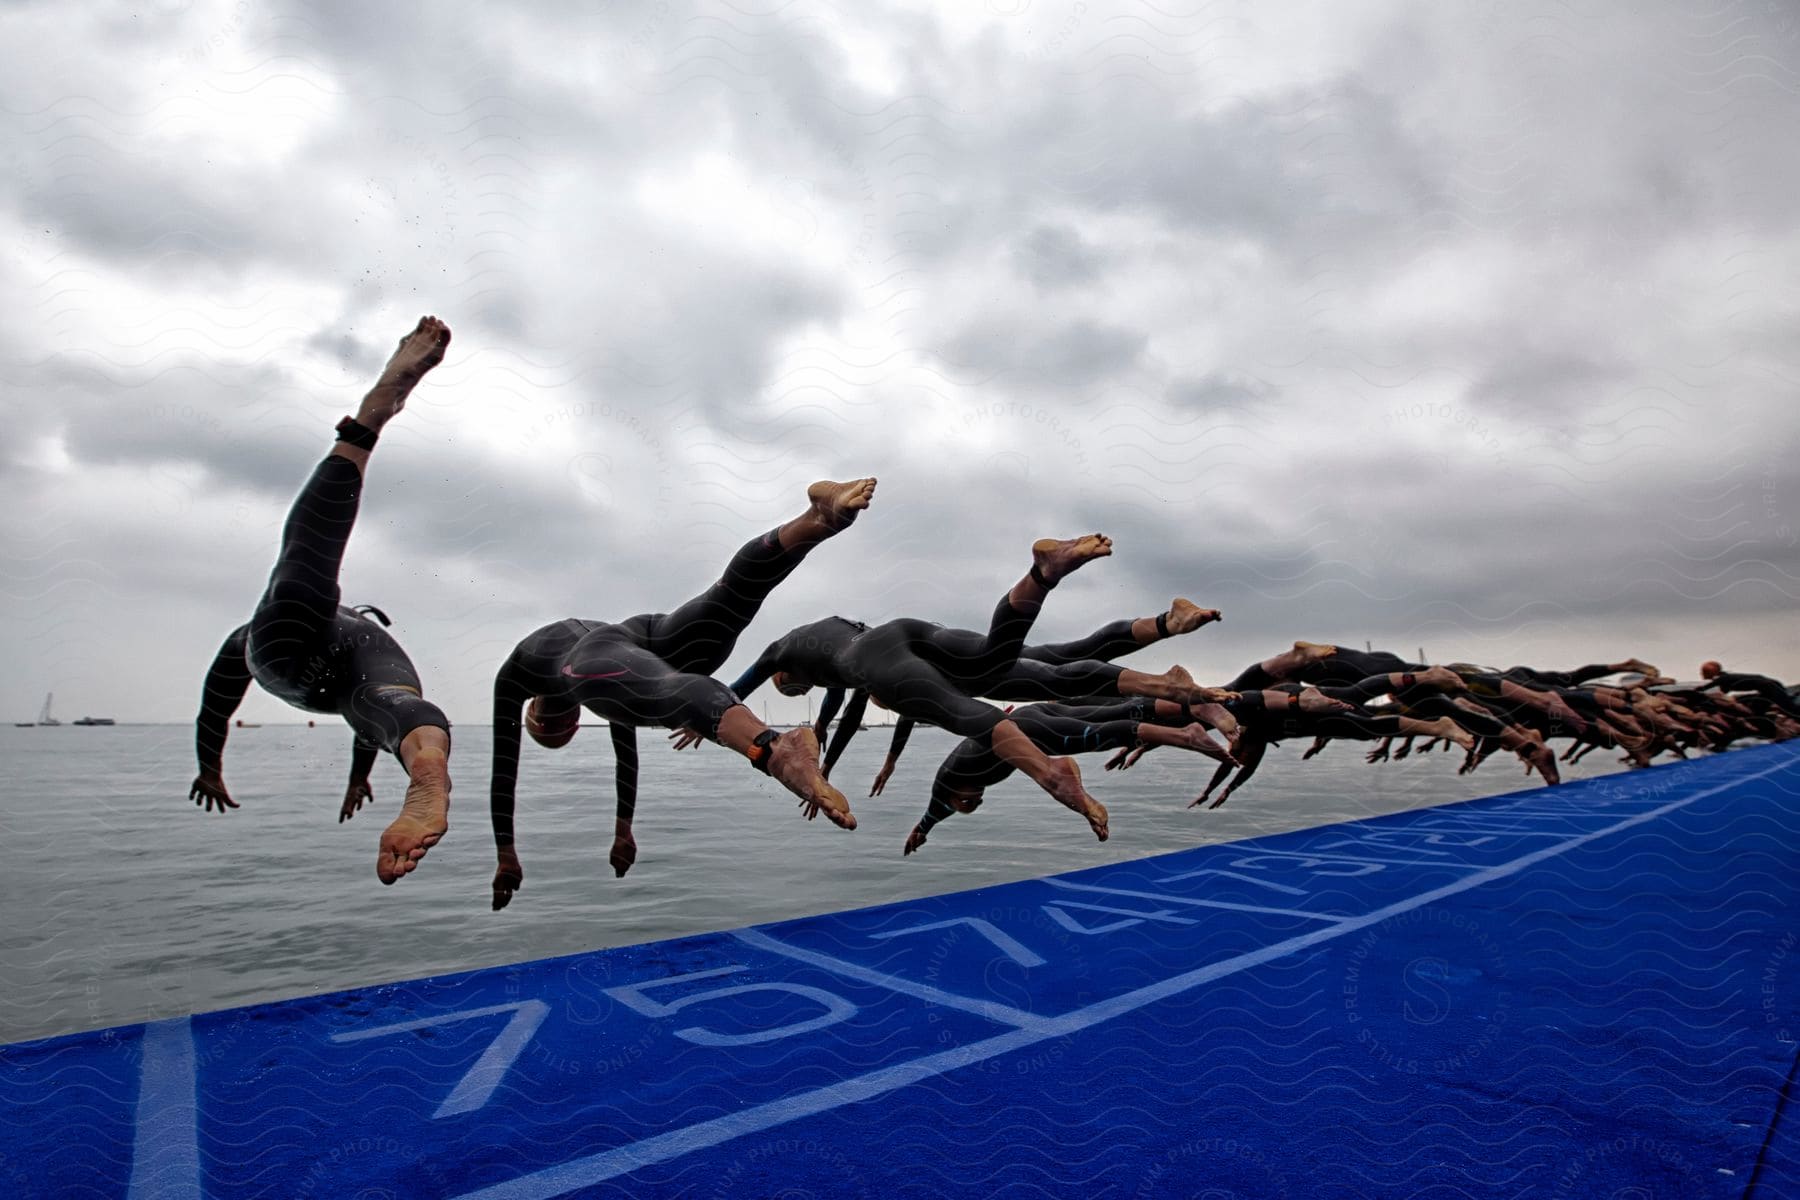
(126, 1016, 200, 1200)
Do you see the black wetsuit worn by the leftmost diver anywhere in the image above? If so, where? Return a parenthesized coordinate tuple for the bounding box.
(194, 453, 450, 781)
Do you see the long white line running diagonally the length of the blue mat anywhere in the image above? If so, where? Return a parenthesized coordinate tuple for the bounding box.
(455, 759, 1795, 1200)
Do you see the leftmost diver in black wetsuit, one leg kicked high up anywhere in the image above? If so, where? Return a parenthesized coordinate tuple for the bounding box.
(189, 317, 450, 883)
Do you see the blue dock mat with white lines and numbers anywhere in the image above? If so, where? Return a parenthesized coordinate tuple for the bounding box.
(0, 747, 1800, 1200)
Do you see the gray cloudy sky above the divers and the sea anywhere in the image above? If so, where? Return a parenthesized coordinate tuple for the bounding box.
(0, 0, 1800, 721)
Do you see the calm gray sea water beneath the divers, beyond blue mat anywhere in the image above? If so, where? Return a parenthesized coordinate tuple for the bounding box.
(0, 721, 1618, 1042)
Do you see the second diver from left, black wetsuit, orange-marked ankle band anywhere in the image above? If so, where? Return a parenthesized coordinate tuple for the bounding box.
(490, 479, 875, 910)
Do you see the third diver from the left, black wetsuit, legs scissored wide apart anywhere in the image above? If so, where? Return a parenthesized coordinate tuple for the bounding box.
(723, 534, 1112, 842)
